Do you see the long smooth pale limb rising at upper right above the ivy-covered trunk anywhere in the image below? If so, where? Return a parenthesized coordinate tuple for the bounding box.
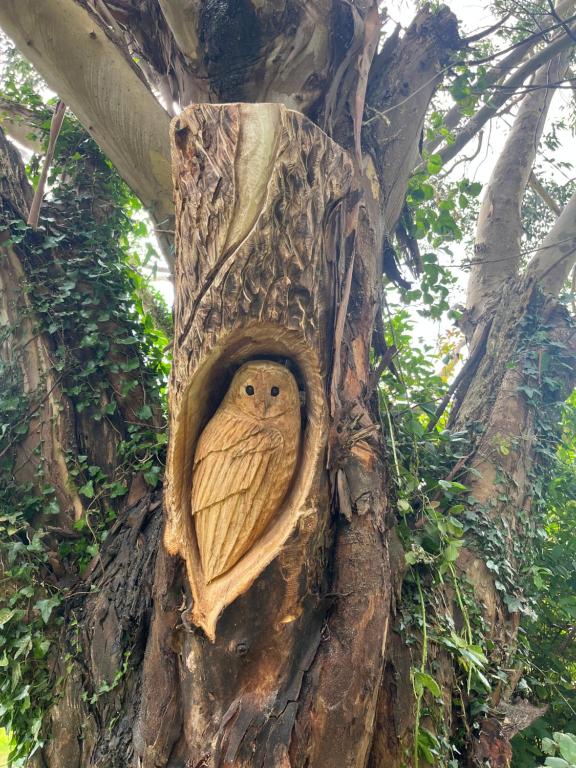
(467, 52, 569, 316)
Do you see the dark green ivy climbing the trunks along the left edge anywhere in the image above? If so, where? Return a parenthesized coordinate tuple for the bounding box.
(0, 49, 170, 766)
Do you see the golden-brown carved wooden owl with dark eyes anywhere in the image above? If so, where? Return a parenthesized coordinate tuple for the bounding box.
(192, 360, 300, 583)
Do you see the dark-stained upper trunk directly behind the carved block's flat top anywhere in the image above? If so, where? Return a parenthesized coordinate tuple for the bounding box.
(159, 0, 338, 114)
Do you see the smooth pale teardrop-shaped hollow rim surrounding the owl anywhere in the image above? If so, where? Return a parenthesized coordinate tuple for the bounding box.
(165, 323, 328, 640)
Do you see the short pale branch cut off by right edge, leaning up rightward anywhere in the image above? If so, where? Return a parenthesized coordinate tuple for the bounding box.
(527, 193, 576, 296)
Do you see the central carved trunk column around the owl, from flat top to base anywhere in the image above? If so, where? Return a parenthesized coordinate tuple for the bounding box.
(160, 104, 352, 765)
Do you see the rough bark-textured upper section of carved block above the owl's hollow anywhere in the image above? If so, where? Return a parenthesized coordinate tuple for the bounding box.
(175, 105, 351, 364)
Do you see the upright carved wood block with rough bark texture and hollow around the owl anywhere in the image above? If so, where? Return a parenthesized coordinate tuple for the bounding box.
(165, 104, 352, 640)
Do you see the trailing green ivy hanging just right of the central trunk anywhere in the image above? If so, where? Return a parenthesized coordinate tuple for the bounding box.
(380, 310, 490, 766)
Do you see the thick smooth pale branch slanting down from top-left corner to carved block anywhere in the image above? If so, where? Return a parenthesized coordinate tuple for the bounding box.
(0, 0, 173, 226)
